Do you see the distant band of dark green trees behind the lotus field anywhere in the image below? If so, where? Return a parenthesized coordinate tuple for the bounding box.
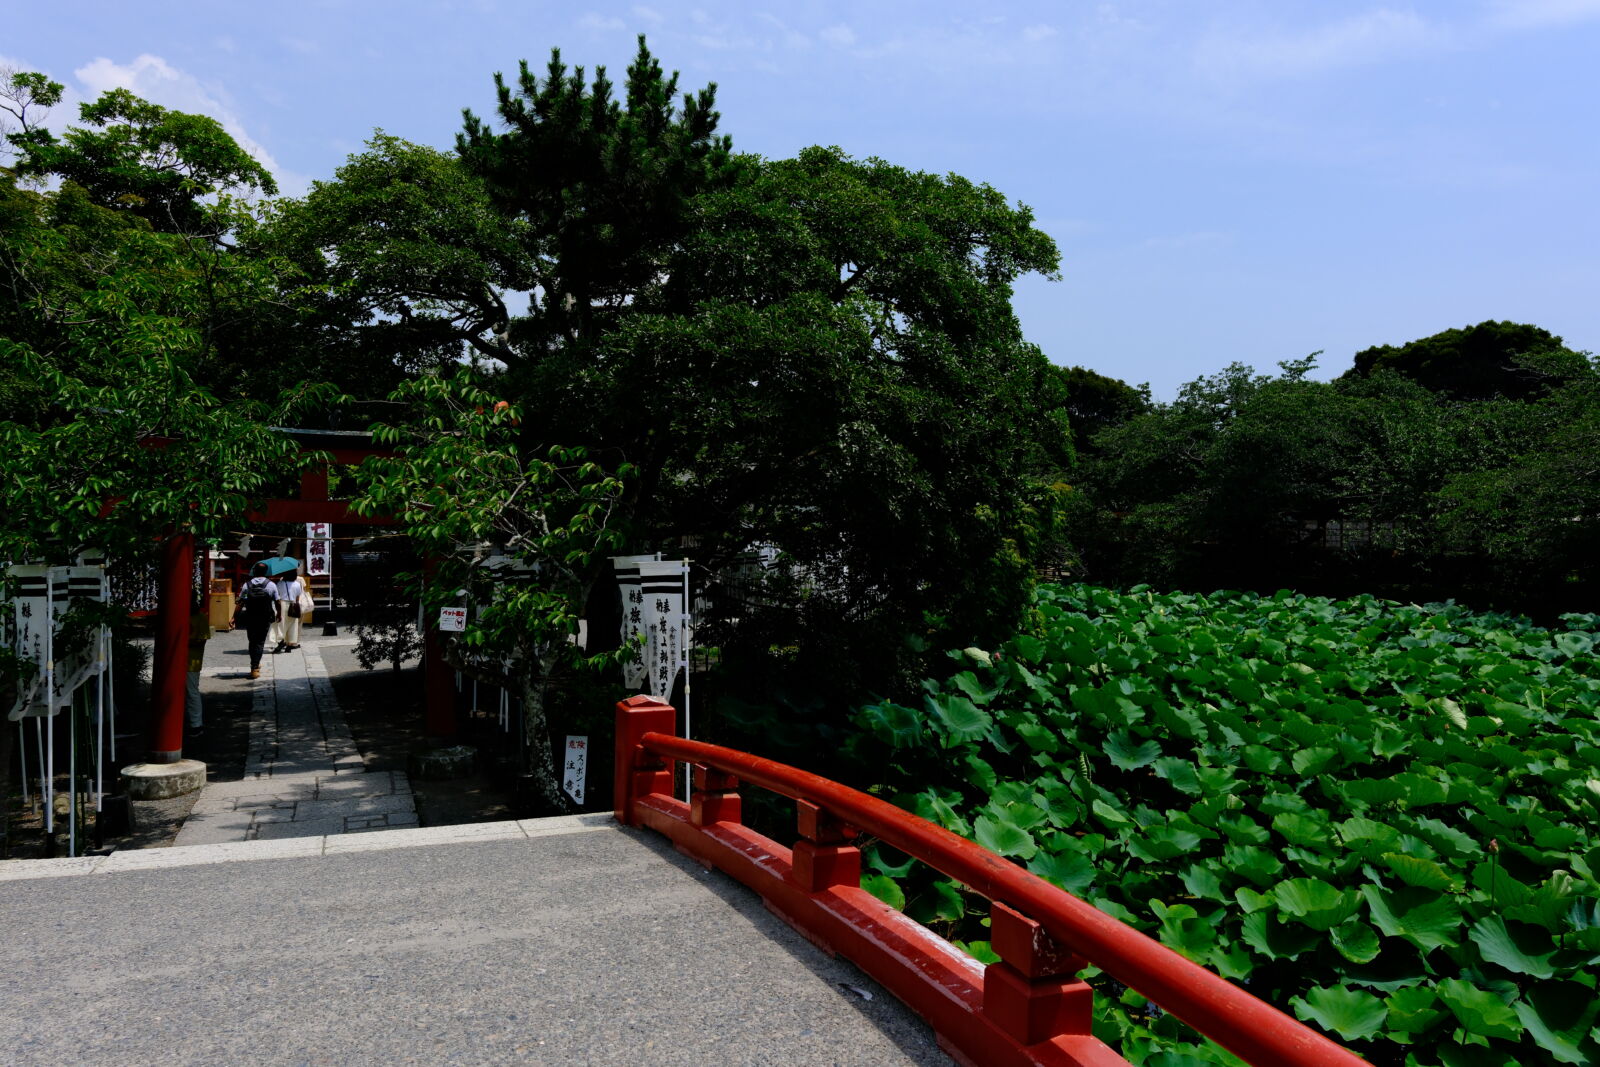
(1062, 322, 1600, 621)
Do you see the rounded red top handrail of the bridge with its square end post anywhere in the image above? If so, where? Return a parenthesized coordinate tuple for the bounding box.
(618, 697, 1365, 1067)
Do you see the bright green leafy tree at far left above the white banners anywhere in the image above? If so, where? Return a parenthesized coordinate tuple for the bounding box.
(0, 75, 325, 560)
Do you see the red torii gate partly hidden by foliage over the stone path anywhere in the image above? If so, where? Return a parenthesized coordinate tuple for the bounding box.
(149, 429, 456, 763)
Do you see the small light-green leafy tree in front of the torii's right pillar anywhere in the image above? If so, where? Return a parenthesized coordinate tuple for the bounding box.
(355, 368, 632, 811)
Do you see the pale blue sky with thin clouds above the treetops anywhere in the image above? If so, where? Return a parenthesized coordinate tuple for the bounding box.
(0, 0, 1600, 398)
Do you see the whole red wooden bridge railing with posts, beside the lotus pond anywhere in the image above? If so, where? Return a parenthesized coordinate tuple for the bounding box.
(616, 696, 1365, 1067)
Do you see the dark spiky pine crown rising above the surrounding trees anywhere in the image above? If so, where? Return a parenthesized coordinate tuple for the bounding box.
(456, 37, 741, 363)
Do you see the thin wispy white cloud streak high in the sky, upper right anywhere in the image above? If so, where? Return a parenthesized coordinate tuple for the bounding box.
(1195, 8, 1446, 82)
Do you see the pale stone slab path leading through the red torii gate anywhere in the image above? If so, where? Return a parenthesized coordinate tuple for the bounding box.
(174, 632, 418, 846)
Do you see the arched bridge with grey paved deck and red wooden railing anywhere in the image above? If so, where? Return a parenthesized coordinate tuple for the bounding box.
(0, 697, 1362, 1067)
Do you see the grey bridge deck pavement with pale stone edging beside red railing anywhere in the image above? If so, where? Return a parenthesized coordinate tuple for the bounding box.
(0, 814, 950, 1065)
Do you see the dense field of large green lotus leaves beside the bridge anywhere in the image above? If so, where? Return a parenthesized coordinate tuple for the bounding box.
(858, 585, 1600, 1067)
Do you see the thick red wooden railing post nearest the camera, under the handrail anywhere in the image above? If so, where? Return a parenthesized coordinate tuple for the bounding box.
(984, 901, 1094, 1045)
